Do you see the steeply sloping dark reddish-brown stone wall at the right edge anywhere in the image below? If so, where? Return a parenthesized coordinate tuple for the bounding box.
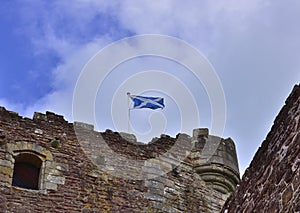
(223, 85, 300, 213)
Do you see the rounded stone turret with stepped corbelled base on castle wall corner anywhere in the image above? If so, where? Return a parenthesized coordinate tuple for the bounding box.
(191, 129, 240, 194)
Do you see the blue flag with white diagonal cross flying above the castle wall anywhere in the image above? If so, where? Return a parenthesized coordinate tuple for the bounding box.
(130, 95, 165, 109)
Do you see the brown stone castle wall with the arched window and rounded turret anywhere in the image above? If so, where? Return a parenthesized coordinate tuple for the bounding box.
(0, 104, 239, 213)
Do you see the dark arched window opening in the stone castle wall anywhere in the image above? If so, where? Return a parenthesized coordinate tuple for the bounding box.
(12, 153, 42, 190)
